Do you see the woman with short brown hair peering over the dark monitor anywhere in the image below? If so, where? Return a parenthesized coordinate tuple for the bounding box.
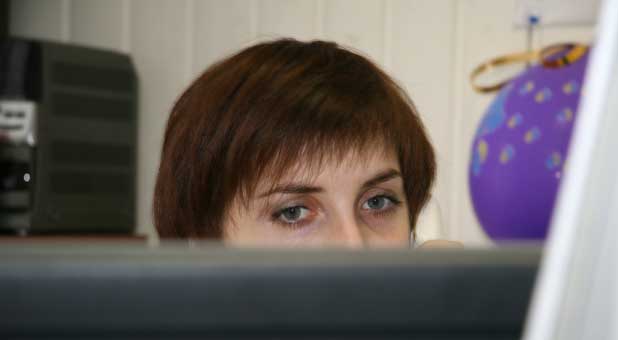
(154, 39, 452, 246)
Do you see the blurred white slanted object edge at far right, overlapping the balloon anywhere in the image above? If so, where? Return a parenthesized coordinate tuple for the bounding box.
(524, 0, 618, 340)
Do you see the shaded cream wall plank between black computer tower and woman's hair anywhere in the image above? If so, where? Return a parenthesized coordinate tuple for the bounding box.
(130, 0, 191, 239)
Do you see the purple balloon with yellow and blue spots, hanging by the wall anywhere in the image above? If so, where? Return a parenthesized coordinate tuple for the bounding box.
(468, 53, 588, 240)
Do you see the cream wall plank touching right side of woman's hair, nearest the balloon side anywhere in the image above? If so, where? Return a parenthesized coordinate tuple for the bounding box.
(385, 0, 454, 236)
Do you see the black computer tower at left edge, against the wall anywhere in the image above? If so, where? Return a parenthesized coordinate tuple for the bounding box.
(0, 38, 137, 234)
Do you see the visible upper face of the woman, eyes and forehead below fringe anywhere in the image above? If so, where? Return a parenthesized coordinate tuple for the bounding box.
(223, 150, 410, 247)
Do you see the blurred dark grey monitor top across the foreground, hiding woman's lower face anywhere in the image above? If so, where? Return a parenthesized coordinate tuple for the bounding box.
(0, 244, 540, 340)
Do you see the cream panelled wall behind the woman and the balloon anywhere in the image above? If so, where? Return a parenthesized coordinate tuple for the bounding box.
(10, 0, 592, 244)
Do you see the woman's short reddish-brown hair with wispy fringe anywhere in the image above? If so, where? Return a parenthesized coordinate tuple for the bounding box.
(153, 39, 436, 238)
